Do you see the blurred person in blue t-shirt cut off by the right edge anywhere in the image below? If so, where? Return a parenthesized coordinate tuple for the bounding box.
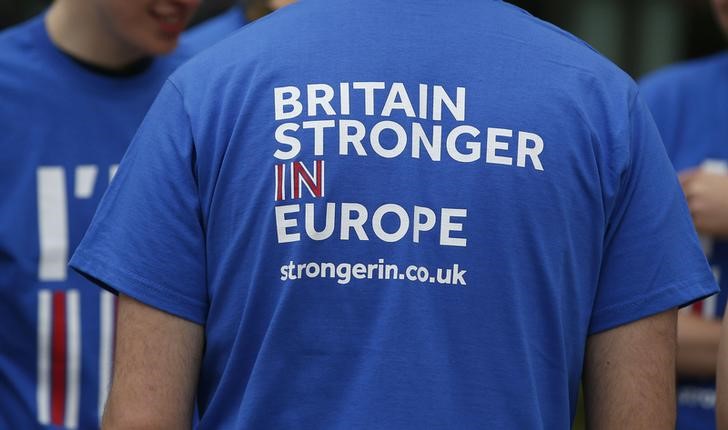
(641, 0, 728, 430)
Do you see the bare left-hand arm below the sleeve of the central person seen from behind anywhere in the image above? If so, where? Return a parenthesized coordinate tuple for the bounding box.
(102, 295, 204, 430)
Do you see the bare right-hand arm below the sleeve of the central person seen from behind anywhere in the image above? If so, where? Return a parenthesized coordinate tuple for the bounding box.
(584, 309, 677, 430)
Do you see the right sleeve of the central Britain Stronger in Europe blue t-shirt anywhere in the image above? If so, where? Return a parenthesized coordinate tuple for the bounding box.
(589, 92, 718, 334)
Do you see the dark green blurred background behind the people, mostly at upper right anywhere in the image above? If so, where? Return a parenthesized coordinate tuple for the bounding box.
(0, 0, 726, 429)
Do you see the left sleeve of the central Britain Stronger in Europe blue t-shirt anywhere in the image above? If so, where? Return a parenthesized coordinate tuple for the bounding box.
(70, 81, 208, 324)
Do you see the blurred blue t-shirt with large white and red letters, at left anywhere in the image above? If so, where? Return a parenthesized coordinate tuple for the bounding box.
(0, 11, 193, 429)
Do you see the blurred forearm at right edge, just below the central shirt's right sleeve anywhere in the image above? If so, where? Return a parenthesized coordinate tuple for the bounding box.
(677, 310, 720, 379)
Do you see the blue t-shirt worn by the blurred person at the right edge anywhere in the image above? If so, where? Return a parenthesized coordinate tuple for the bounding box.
(641, 53, 728, 430)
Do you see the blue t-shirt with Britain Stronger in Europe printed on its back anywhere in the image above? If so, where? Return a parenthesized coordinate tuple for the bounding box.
(71, 0, 716, 429)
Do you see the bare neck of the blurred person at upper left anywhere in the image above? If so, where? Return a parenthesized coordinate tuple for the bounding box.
(45, 0, 145, 69)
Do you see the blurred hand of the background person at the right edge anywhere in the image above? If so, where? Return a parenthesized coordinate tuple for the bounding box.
(679, 169, 728, 237)
